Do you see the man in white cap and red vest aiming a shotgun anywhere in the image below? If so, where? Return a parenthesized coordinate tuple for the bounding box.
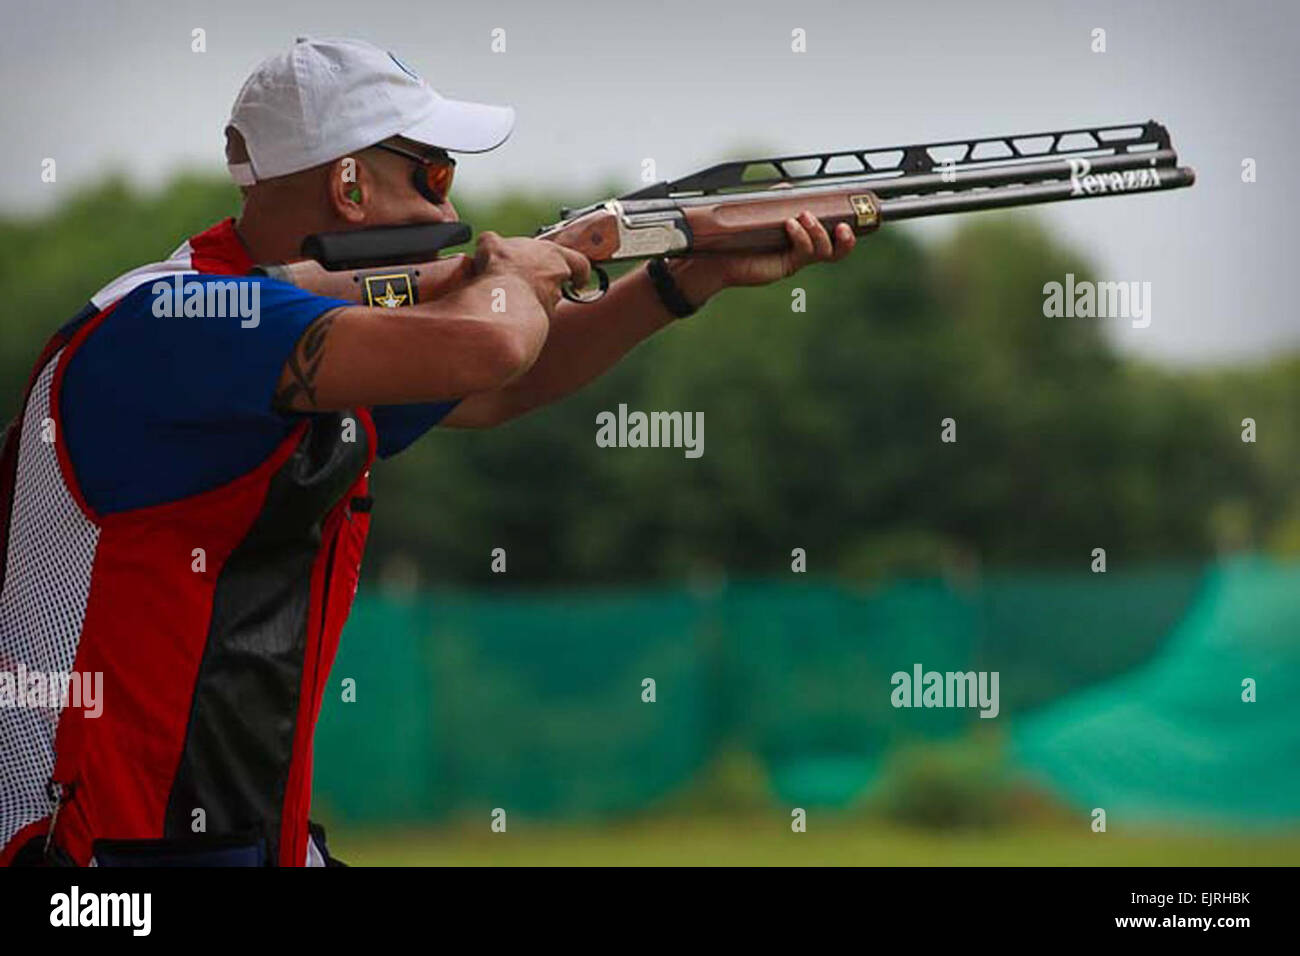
(0, 39, 853, 866)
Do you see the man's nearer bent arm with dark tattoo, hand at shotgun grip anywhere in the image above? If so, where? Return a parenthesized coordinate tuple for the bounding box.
(276, 233, 590, 412)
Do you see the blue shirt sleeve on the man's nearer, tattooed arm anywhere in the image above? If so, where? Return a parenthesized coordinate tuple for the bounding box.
(60, 276, 354, 514)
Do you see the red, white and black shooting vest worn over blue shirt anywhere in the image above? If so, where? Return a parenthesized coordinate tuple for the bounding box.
(0, 220, 376, 866)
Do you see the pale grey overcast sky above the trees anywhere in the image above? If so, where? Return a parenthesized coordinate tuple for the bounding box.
(0, 0, 1300, 364)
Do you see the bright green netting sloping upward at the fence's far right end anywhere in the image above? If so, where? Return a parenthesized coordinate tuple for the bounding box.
(1014, 559, 1300, 825)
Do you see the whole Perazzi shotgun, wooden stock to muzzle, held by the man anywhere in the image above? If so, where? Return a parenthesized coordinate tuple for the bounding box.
(264, 120, 1196, 306)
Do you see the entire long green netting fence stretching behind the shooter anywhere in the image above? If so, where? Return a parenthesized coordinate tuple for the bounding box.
(315, 561, 1300, 823)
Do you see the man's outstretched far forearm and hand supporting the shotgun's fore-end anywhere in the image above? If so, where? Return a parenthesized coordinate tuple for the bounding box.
(441, 213, 855, 428)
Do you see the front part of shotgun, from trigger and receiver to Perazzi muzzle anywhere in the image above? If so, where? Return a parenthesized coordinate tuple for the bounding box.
(537, 120, 1196, 302)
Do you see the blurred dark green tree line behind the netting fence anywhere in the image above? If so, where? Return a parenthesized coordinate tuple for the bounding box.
(0, 176, 1300, 585)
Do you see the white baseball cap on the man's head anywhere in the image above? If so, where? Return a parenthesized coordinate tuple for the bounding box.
(228, 36, 515, 186)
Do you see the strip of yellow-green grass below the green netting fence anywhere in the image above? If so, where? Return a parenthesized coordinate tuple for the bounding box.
(330, 814, 1300, 866)
